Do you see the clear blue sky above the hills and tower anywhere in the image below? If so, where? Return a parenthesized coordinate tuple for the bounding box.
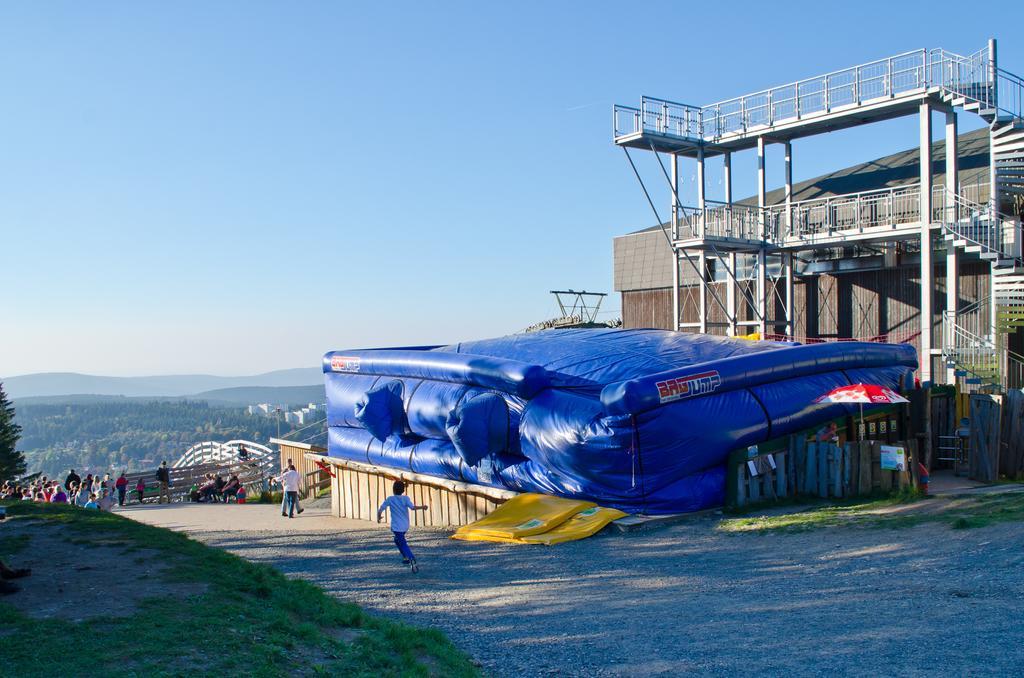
(0, 1, 1024, 376)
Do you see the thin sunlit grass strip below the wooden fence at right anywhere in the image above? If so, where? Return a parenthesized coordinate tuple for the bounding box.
(718, 493, 1024, 533)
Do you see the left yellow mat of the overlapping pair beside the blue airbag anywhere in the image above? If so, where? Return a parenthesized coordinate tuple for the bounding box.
(455, 494, 596, 541)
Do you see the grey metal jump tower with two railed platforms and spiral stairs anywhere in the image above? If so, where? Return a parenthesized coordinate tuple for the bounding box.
(613, 40, 1024, 387)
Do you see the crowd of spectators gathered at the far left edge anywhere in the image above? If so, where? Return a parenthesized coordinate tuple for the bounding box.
(0, 469, 145, 511)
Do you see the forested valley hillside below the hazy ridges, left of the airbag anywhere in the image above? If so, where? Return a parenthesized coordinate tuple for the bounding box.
(15, 400, 312, 475)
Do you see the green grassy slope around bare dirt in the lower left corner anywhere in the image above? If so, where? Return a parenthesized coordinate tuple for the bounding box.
(0, 504, 477, 676)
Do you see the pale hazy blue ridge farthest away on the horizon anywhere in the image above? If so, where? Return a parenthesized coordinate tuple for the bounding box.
(0, 367, 324, 402)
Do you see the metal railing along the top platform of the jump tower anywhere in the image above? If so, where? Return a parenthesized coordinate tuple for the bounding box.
(612, 42, 1024, 142)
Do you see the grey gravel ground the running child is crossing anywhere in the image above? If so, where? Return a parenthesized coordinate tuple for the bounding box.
(123, 507, 1024, 676)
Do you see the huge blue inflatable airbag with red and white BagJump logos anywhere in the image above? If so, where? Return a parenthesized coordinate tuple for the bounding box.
(324, 329, 918, 513)
